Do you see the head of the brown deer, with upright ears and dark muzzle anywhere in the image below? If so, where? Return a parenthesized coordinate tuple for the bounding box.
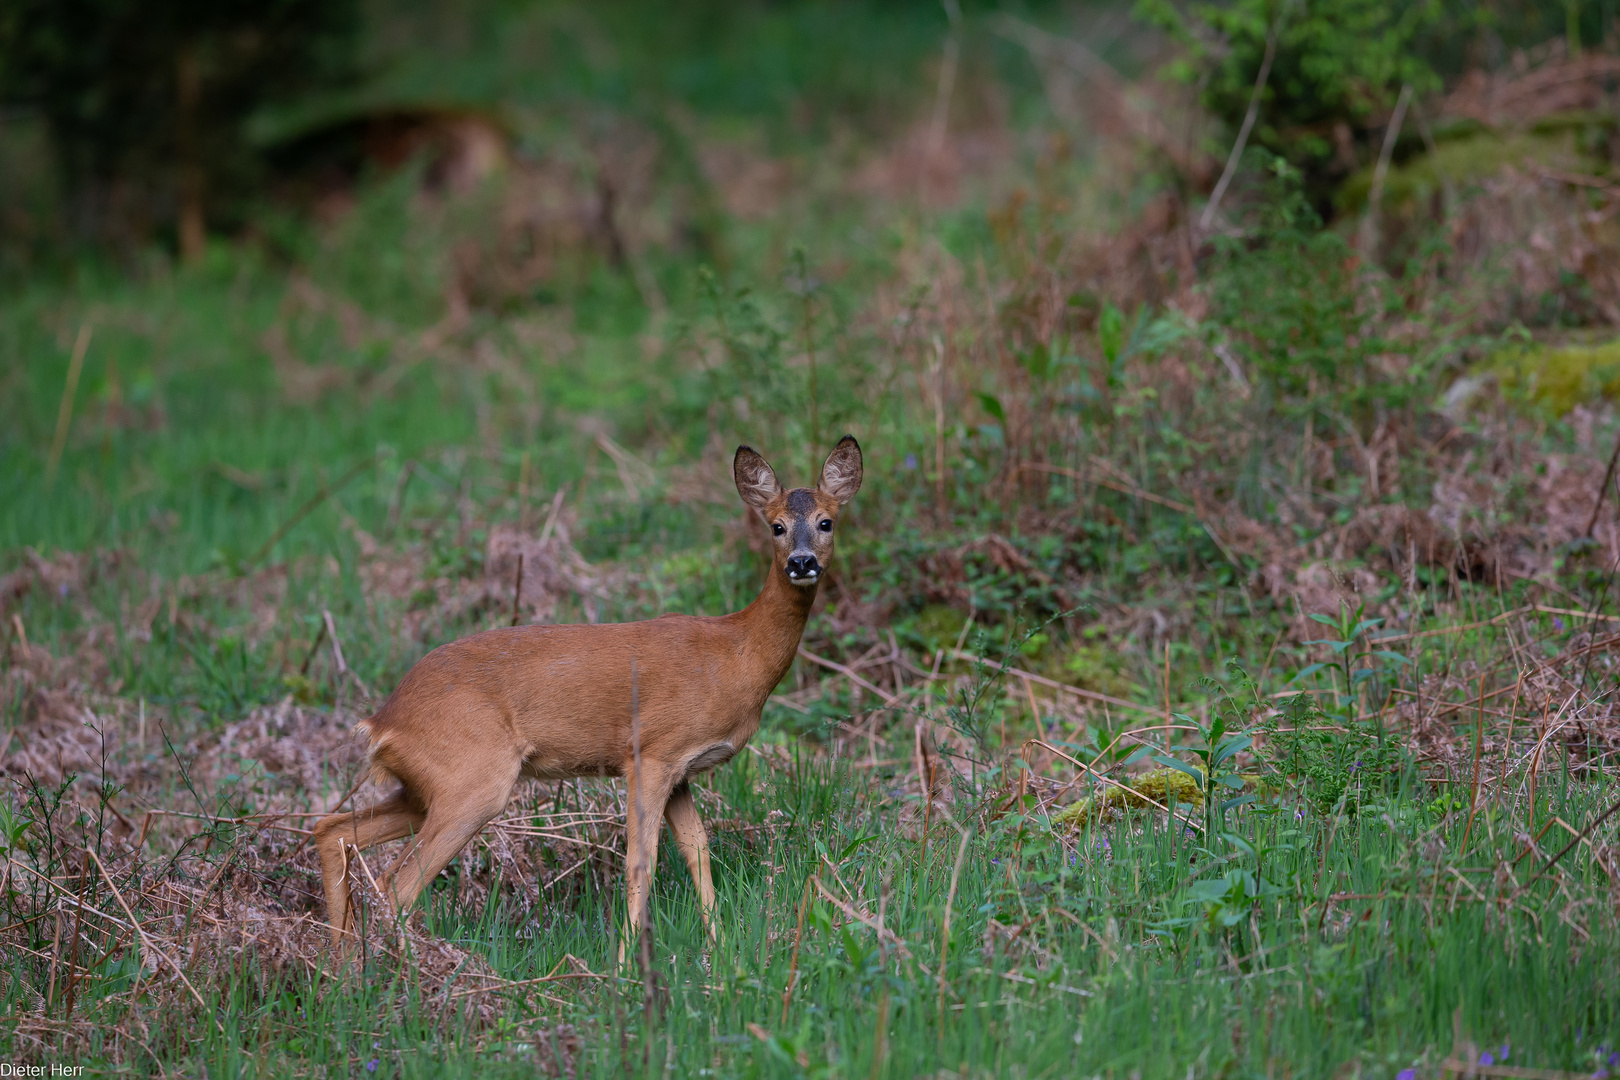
(732, 436, 860, 588)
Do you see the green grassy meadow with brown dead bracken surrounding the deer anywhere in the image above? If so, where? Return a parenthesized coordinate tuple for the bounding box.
(0, 5, 1620, 1080)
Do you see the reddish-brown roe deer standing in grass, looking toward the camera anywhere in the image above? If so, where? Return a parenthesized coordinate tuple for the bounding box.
(314, 436, 862, 949)
